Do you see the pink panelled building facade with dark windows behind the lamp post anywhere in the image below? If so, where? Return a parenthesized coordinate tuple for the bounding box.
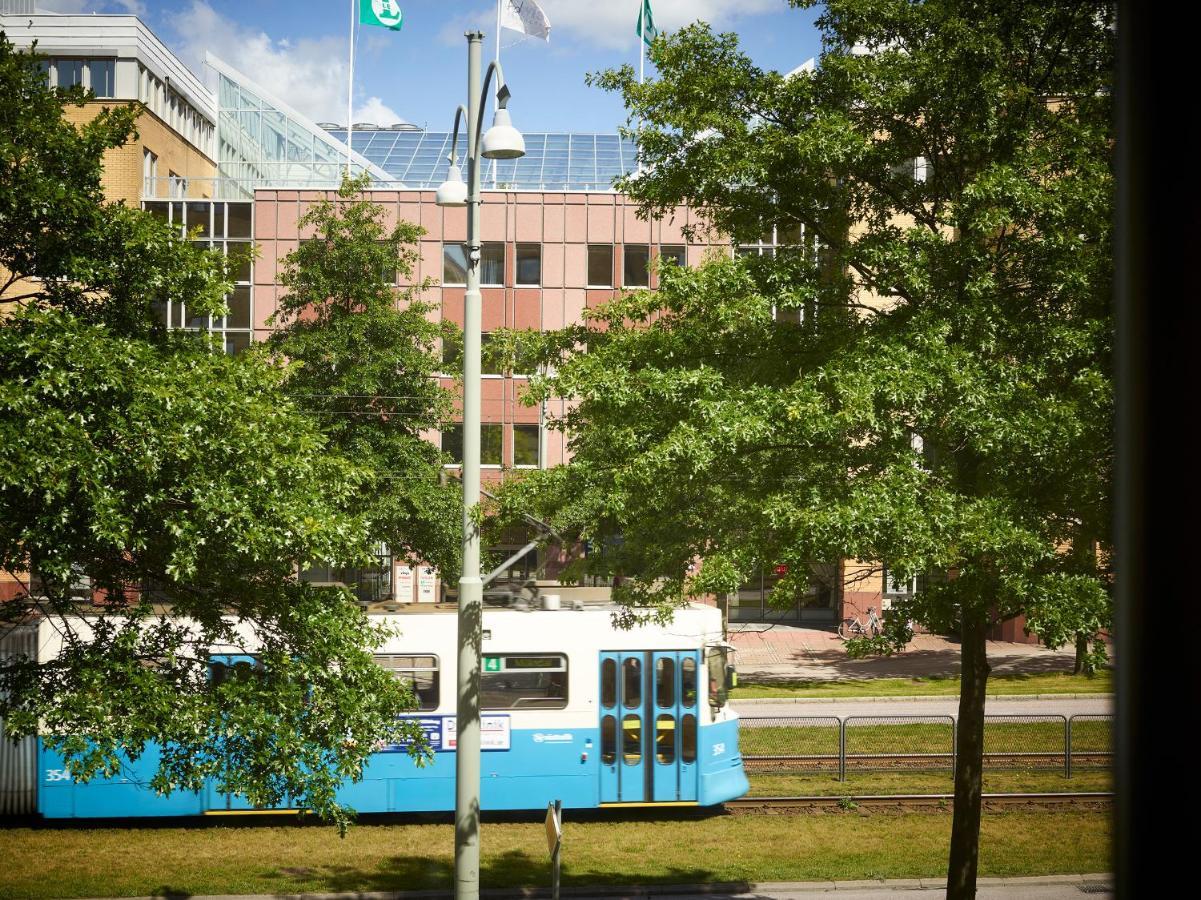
(253, 190, 715, 479)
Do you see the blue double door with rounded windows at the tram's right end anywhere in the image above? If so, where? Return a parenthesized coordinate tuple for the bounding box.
(601, 650, 700, 803)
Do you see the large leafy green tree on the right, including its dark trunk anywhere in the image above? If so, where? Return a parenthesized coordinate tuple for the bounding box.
(506, 0, 1113, 898)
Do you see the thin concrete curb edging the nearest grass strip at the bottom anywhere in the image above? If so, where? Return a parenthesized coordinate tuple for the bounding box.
(96, 874, 1113, 900)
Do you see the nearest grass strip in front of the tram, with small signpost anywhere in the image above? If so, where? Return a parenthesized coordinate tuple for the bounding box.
(0, 809, 1111, 898)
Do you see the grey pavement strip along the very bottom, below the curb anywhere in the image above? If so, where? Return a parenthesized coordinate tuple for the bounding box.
(98, 875, 1113, 900)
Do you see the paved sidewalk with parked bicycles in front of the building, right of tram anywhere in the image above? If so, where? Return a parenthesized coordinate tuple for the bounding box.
(728, 622, 1090, 683)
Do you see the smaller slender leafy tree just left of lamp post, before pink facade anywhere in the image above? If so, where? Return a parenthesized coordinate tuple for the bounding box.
(267, 179, 461, 576)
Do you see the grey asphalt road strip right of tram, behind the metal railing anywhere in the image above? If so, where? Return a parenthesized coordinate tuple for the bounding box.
(730, 695, 1113, 719)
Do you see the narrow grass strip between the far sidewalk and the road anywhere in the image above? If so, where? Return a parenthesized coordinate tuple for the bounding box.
(730, 669, 1113, 701)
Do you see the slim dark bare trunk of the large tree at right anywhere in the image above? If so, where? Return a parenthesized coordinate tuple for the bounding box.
(946, 609, 990, 900)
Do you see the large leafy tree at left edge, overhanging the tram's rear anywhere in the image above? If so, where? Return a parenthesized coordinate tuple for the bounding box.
(0, 35, 425, 824)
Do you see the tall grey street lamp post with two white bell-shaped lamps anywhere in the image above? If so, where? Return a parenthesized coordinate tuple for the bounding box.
(435, 31, 525, 900)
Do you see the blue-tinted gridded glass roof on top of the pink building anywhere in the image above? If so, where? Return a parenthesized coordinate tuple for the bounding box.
(327, 127, 638, 191)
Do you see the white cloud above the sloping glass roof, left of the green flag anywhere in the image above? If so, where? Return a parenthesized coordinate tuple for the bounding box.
(169, 0, 391, 125)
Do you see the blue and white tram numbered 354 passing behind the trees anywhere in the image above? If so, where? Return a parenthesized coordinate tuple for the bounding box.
(28, 604, 749, 818)
